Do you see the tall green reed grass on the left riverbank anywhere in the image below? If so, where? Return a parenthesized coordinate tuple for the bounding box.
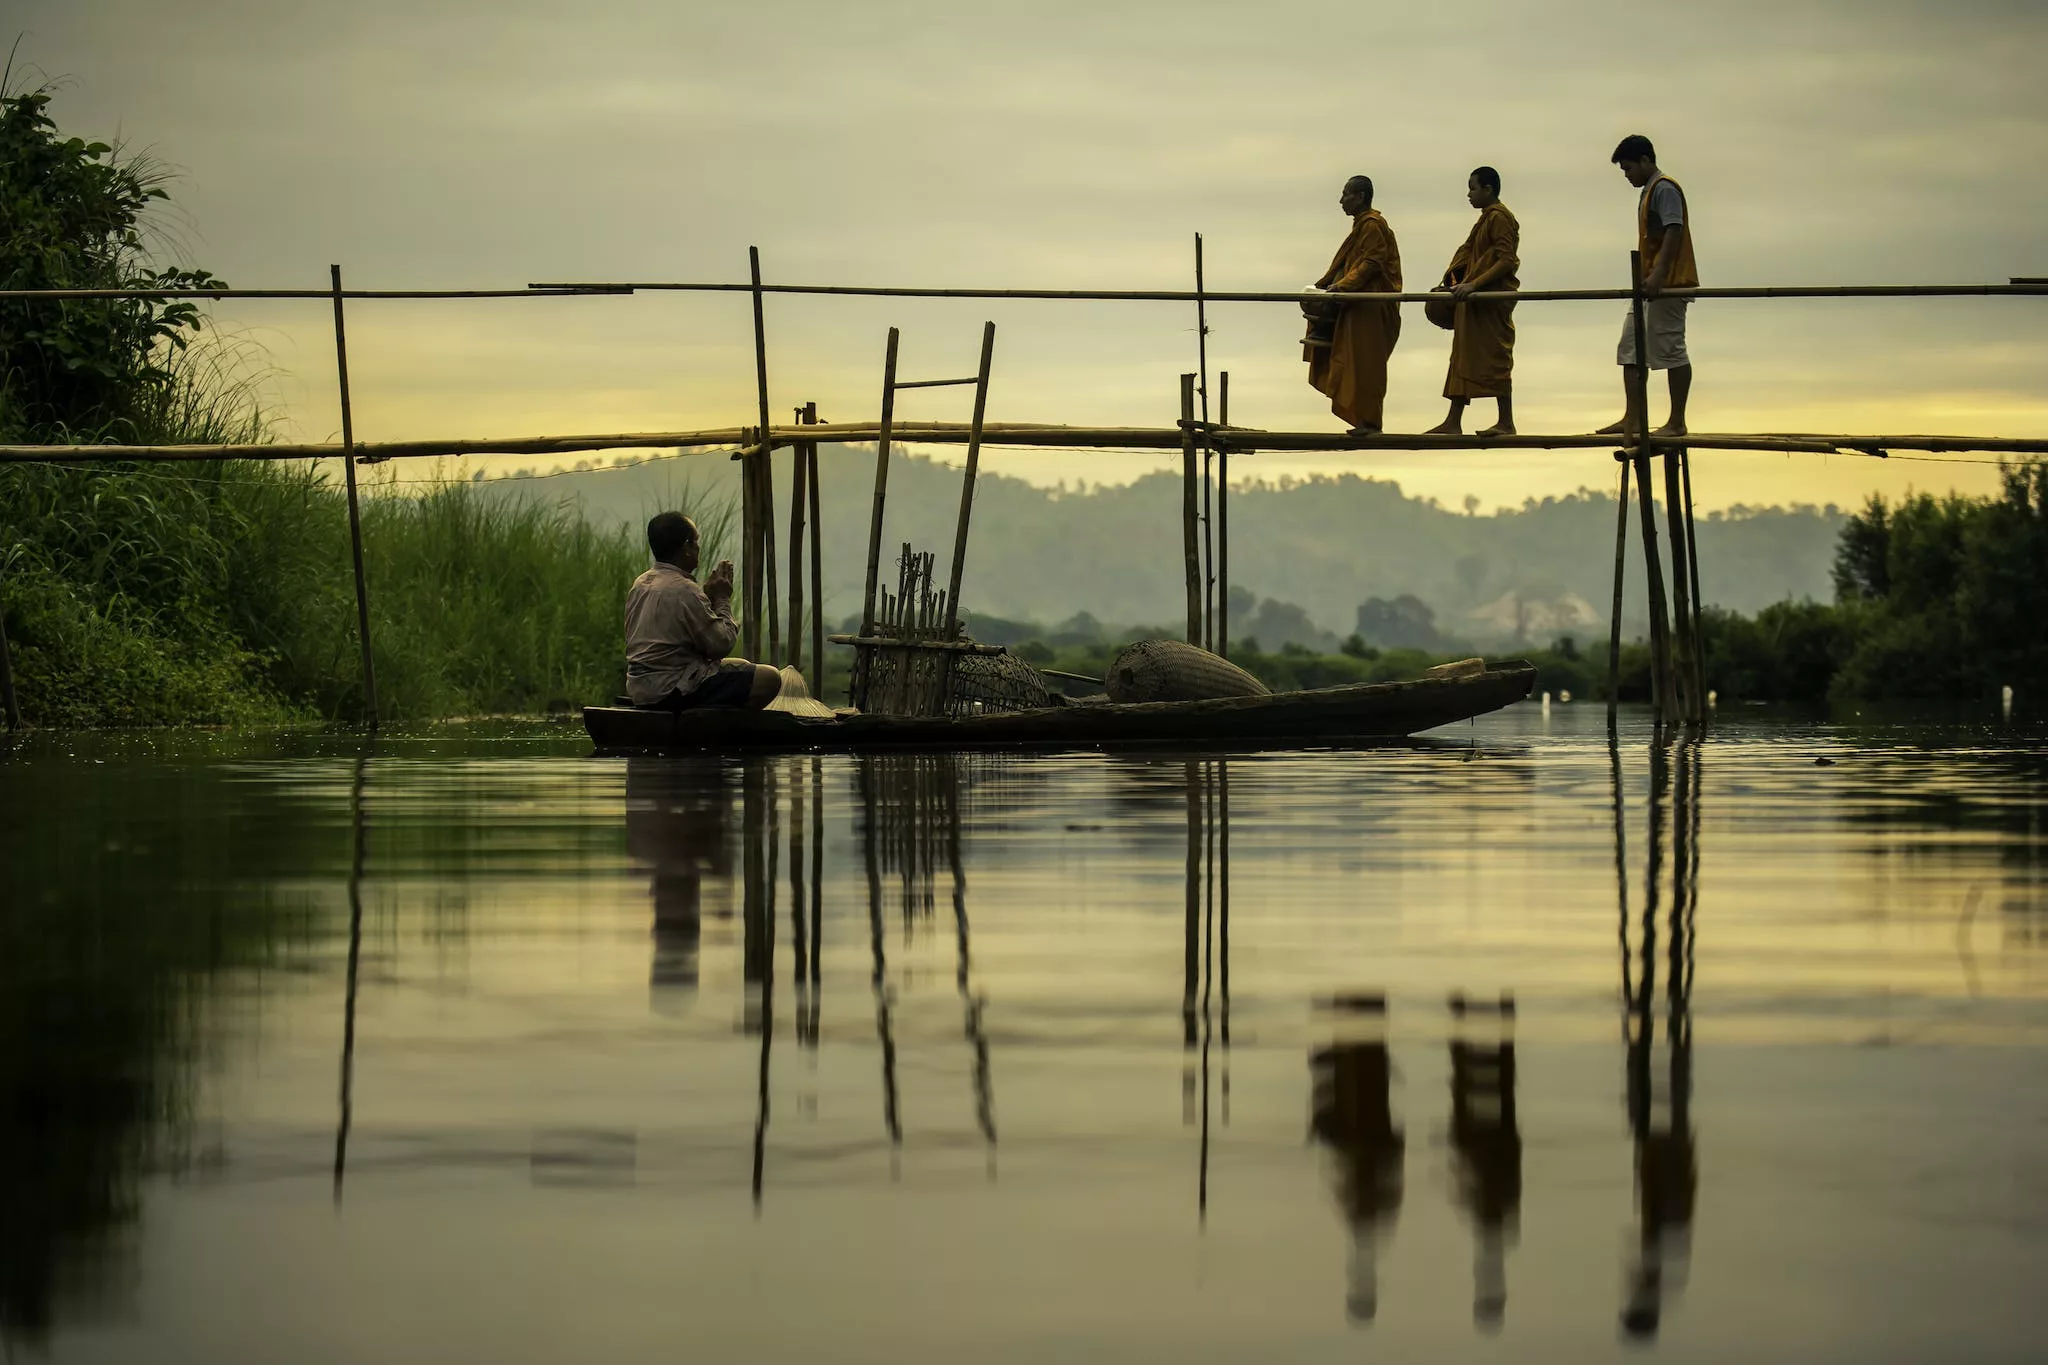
(0, 446, 731, 724)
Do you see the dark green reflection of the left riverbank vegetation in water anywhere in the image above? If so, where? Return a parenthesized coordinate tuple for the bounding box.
(0, 757, 321, 1359)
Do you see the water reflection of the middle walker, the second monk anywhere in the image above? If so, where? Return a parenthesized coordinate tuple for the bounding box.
(1450, 995, 1522, 1328)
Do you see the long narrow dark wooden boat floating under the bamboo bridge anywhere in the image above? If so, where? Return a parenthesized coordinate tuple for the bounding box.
(584, 659, 1536, 753)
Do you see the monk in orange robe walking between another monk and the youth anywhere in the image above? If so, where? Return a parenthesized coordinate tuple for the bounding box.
(1430, 166, 1522, 436)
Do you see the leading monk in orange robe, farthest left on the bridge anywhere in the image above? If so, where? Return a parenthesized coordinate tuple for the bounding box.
(1303, 176, 1401, 436)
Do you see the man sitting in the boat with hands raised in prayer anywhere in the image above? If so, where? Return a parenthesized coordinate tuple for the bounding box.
(627, 512, 782, 710)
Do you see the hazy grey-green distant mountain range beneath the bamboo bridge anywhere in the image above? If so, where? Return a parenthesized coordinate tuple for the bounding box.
(485, 446, 1845, 647)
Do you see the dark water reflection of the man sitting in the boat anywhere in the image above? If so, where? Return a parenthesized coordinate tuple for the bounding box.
(627, 759, 733, 990)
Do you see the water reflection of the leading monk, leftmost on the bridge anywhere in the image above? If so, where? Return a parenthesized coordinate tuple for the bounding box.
(1309, 995, 1405, 1322)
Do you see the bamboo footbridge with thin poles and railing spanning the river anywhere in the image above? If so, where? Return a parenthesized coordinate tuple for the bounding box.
(0, 258, 2048, 729)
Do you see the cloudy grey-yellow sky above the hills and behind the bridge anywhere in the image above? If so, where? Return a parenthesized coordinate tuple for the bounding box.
(16, 0, 2048, 508)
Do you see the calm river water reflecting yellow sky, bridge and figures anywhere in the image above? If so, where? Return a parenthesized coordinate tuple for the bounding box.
(0, 706, 2048, 1363)
